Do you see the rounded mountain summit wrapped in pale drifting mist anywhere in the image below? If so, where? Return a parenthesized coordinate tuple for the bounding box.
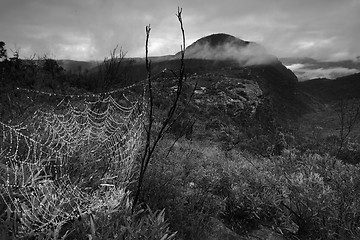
(185, 33, 278, 66)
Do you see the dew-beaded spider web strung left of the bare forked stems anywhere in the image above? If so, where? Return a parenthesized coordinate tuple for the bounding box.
(0, 84, 146, 236)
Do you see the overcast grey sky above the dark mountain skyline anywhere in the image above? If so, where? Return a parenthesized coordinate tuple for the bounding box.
(0, 0, 360, 60)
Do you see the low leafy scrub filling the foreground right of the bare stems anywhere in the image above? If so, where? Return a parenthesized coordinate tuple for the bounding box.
(143, 140, 360, 239)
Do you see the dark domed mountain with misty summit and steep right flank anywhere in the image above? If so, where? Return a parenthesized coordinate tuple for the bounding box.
(177, 33, 304, 115)
